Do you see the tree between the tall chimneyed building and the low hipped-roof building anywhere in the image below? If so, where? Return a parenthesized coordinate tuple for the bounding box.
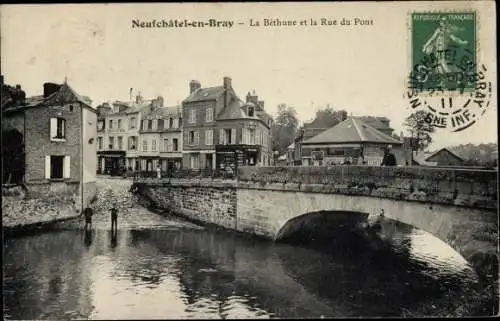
(272, 104, 299, 154)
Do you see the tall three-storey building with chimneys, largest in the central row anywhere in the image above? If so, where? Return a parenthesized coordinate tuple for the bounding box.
(182, 77, 272, 169)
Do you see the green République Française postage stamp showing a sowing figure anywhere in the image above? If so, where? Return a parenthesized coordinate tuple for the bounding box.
(410, 12, 477, 92)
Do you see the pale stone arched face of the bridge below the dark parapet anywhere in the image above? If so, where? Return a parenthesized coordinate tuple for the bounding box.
(238, 189, 498, 276)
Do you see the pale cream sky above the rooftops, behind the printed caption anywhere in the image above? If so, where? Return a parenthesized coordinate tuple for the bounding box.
(0, 1, 497, 148)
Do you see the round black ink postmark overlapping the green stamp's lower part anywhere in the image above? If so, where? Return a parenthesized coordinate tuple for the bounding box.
(406, 49, 492, 132)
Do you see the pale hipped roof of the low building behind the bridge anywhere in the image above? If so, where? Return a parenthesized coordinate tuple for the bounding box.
(303, 117, 402, 145)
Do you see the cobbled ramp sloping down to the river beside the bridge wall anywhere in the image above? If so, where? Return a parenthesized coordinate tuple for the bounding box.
(78, 177, 201, 230)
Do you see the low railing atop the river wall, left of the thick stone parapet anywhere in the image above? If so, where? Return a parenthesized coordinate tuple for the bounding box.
(129, 169, 236, 180)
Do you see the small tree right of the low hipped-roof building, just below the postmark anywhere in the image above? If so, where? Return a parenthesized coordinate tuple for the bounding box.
(404, 110, 434, 152)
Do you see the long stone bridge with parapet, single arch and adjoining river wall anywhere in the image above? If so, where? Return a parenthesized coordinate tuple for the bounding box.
(136, 166, 498, 277)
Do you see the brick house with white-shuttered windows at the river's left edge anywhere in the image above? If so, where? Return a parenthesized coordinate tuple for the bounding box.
(2, 79, 97, 207)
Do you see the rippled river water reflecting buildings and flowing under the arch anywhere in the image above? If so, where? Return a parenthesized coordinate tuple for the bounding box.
(3, 178, 496, 320)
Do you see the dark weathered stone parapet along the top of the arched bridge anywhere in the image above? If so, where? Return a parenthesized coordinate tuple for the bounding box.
(238, 166, 498, 210)
